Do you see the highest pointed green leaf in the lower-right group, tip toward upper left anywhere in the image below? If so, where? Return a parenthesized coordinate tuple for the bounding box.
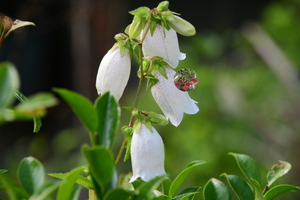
(229, 153, 261, 184)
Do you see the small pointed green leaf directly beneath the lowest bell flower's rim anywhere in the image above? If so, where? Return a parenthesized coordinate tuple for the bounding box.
(136, 175, 167, 200)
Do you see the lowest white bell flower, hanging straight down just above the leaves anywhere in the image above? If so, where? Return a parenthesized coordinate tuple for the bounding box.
(130, 124, 166, 182)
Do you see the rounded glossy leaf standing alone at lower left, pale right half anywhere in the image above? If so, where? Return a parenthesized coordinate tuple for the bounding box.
(17, 157, 45, 194)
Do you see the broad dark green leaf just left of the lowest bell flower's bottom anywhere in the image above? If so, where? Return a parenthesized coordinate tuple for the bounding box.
(82, 145, 115, 198)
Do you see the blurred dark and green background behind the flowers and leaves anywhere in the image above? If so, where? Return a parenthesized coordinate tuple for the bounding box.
(0, 0, 300, 200)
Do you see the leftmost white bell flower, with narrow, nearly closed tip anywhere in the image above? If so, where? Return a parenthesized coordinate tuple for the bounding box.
(96, 46, 131, 101)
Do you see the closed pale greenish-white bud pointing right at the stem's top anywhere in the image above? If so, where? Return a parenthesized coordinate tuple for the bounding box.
(167, 15, 196, 36)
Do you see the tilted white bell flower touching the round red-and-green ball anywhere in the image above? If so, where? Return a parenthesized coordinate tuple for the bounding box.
(151, 67, 199, 126)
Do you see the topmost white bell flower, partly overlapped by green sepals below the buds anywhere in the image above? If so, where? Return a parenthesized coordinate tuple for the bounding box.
(142, 25, 185, 68)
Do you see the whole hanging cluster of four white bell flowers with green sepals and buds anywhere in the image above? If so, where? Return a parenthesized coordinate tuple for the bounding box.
(96, 2, 199, 182)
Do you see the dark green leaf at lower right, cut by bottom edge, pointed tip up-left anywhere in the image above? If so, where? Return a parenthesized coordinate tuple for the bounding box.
(221, 173, 254, 200)
